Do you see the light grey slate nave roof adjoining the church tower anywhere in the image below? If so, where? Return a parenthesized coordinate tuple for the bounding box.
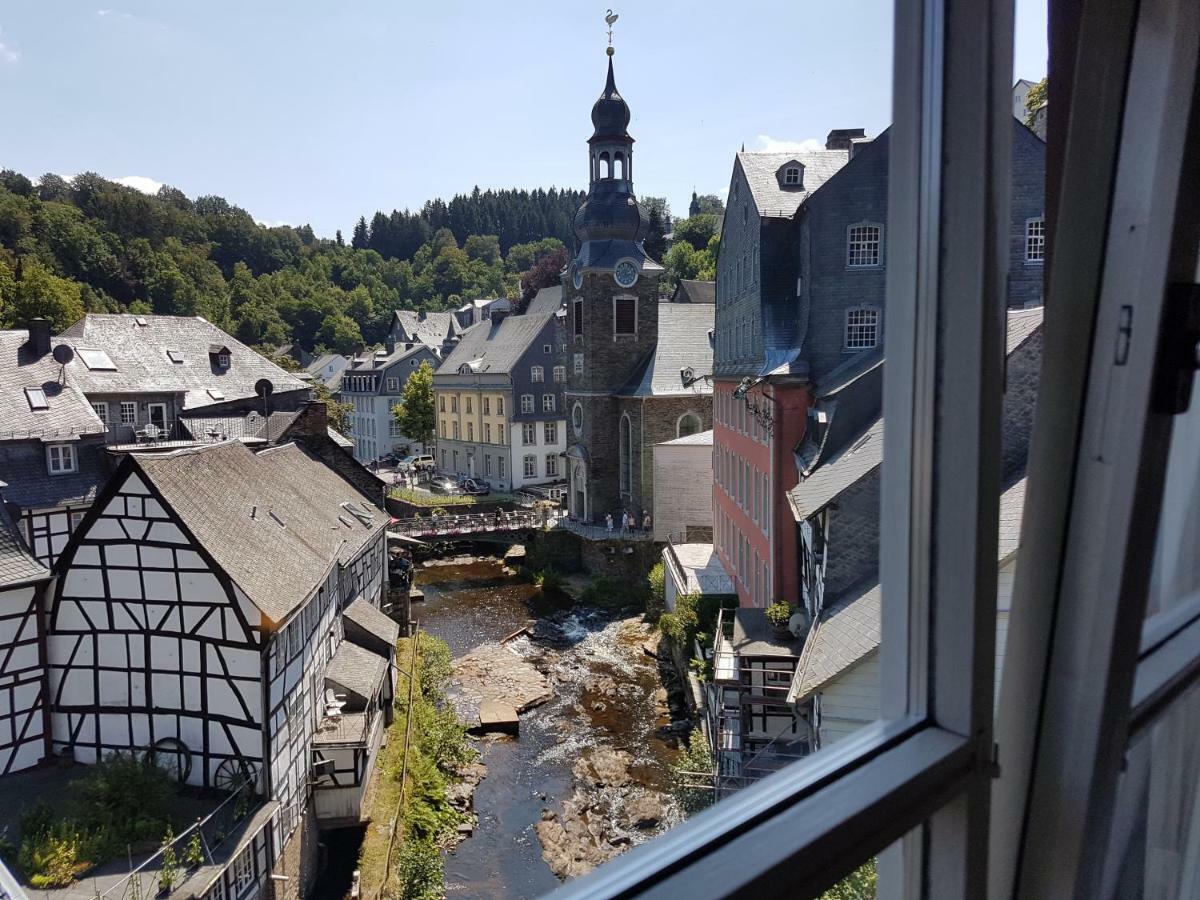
(617, 302, 716, 397)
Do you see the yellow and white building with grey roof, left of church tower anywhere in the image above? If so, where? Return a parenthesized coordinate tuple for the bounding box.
(433, 312, 566, 491)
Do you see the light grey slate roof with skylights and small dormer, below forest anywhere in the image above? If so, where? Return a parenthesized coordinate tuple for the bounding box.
(56, 313, 308, 409)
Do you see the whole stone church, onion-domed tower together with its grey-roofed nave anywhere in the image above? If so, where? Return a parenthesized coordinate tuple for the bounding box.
(563, 47, 715, 522)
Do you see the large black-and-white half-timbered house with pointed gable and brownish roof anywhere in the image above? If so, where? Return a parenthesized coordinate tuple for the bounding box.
(47, 442, 394, 897)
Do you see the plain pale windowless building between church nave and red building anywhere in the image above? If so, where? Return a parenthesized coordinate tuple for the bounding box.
(654, 428, 713, 542)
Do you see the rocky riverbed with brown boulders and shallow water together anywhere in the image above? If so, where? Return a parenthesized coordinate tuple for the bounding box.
(418, 562, 686, 898)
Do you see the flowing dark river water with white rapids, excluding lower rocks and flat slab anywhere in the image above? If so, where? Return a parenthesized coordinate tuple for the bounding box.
(413, 559, 677, 898)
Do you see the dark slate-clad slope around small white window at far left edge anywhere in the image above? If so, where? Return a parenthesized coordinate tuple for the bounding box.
(0, 440, 112, 509)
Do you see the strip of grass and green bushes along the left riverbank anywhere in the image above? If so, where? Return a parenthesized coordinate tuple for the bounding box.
(359, 632, 476, 900)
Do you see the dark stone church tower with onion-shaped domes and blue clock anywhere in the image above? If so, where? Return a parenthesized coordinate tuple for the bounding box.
(563, 46, 662, 522)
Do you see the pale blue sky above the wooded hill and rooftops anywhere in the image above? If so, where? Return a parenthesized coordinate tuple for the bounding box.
(0, 0, 1046, 236)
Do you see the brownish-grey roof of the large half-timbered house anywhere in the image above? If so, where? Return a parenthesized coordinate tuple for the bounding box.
(138, 440, 388, 624)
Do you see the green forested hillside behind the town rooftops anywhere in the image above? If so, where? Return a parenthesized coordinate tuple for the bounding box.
(0, 170, 719, 353)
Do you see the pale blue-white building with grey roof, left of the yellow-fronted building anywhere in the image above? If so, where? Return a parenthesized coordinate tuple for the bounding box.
(341, 342, 438, 463)
